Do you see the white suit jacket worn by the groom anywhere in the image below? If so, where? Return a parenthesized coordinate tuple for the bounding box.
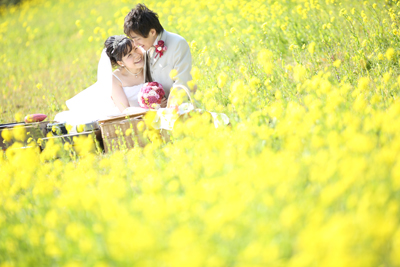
(150, 30, 192, 97)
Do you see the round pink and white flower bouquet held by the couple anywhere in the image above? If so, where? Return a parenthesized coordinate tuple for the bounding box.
(138, 82, 165, 109)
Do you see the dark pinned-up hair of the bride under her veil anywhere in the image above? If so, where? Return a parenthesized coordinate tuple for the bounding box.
(104, 35, 134, 67)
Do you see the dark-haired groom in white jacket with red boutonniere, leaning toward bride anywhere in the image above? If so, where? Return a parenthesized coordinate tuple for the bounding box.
(124, 4, 192, 97)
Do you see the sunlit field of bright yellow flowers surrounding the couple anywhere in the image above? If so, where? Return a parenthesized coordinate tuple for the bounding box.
(0, 0, 400, 267)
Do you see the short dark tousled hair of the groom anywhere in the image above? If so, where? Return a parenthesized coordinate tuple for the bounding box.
(124, 4, 164, 38)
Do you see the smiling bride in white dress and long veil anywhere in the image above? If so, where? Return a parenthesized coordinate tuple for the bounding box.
(54, 35, 167, 126)
